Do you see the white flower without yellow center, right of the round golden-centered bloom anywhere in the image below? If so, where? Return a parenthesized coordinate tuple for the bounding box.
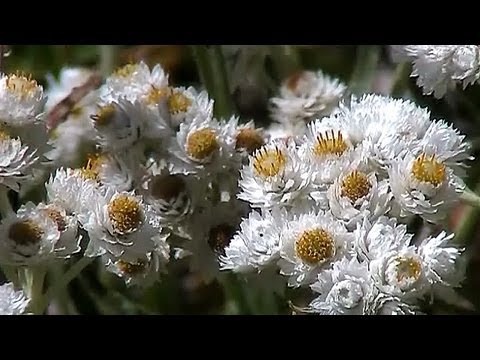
(353, 216, 413, 261)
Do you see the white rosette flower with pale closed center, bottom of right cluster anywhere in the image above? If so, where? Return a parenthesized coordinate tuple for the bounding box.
(309, 258, 374, 315)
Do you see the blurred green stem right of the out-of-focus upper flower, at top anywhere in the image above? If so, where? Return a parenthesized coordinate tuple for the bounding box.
(349, 45, 380, 95)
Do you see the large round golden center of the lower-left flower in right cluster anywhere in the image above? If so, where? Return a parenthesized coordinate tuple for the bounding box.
(295, 228, 335, 266)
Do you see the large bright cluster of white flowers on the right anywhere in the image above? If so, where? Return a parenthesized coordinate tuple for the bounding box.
(221, 83, 470, 314)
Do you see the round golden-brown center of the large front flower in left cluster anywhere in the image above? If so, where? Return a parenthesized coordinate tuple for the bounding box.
(108, 195, 143, 234)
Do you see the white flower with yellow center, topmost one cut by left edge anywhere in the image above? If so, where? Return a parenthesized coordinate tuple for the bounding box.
(0, 73, 47, 127)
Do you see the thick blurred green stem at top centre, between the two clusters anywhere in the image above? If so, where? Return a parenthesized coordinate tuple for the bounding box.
(192, 45, 234, 118)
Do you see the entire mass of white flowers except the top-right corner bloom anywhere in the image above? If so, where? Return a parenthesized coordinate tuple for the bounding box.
(0, 62, 470, 314)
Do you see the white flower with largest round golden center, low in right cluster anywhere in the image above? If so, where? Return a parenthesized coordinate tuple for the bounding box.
(278, 211, 353, 287)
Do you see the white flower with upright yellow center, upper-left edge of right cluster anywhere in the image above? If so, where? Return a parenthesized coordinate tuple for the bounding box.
(237, 141, 314, 208)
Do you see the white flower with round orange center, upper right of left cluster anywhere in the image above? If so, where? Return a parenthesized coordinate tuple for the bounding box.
(169, 115, 234, 175)
